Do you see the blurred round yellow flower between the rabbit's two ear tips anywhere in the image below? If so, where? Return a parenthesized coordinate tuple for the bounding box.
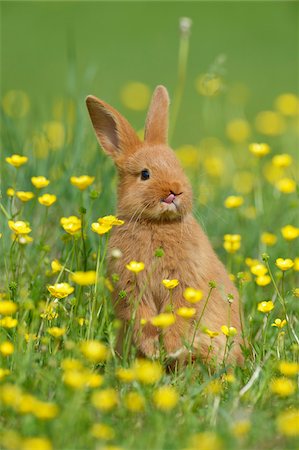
(120, 81, 151, 111)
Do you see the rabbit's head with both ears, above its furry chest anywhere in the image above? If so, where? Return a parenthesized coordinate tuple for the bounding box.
(86, 86, 192, 221)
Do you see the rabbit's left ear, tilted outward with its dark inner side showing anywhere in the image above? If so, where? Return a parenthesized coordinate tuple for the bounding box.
(86, 95, 141, 162)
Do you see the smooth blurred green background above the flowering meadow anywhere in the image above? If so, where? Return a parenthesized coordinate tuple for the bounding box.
(1, 1, 298, 145)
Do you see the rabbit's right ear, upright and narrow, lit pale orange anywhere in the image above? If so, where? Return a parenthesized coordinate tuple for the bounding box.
(144, 86, 169, 144)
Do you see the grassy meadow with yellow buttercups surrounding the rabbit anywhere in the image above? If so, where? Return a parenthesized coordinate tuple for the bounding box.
(0, 2, 299, 450)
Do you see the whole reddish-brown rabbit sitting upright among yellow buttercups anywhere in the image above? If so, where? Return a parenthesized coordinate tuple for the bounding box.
(86, 86, 242, 362)
